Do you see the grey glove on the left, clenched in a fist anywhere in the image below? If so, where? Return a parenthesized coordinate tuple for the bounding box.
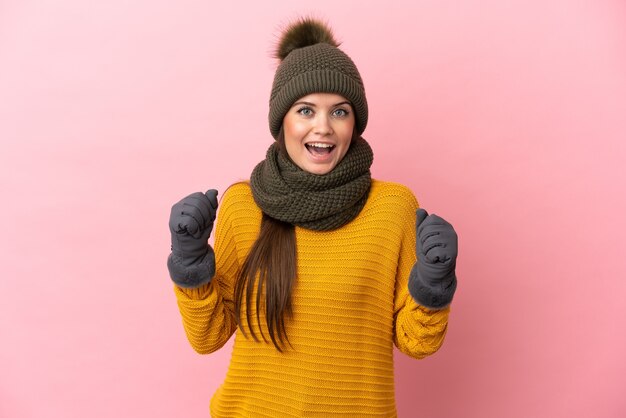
(167, 189, 217, 288)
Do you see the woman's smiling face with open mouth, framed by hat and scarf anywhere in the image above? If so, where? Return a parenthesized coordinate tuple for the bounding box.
(283, 93, 355, 174)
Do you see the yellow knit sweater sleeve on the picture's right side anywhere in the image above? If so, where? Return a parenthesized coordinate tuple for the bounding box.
(394, 189, 450, 359)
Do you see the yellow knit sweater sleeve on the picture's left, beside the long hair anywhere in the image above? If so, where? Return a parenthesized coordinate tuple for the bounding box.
(174, 191, 239, 354)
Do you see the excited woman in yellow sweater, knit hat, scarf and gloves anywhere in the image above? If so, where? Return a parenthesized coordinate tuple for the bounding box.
(167, 19, 458, 418)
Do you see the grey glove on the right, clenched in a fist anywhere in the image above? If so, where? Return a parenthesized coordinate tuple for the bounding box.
(409, 208, 458, 309)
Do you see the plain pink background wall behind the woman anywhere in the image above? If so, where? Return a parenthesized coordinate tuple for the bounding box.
(0, 0, 626, 418)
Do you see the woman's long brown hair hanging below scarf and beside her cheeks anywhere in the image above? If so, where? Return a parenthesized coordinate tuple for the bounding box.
(234, 127, 359, 353)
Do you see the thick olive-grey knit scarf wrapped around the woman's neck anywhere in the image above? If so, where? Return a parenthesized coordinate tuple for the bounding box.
(250, 137, 374, 231)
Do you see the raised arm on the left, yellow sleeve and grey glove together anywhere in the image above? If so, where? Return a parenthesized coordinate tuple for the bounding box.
(167, 190, 238, 354)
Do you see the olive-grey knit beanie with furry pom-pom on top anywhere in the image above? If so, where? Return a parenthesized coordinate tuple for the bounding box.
(269, 18, 367, 139)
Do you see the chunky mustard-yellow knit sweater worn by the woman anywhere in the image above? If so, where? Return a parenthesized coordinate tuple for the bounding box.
(174, 180, 450, 418)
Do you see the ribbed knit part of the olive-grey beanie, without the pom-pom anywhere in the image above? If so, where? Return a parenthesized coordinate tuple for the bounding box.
(269, 43, 368, 138)
